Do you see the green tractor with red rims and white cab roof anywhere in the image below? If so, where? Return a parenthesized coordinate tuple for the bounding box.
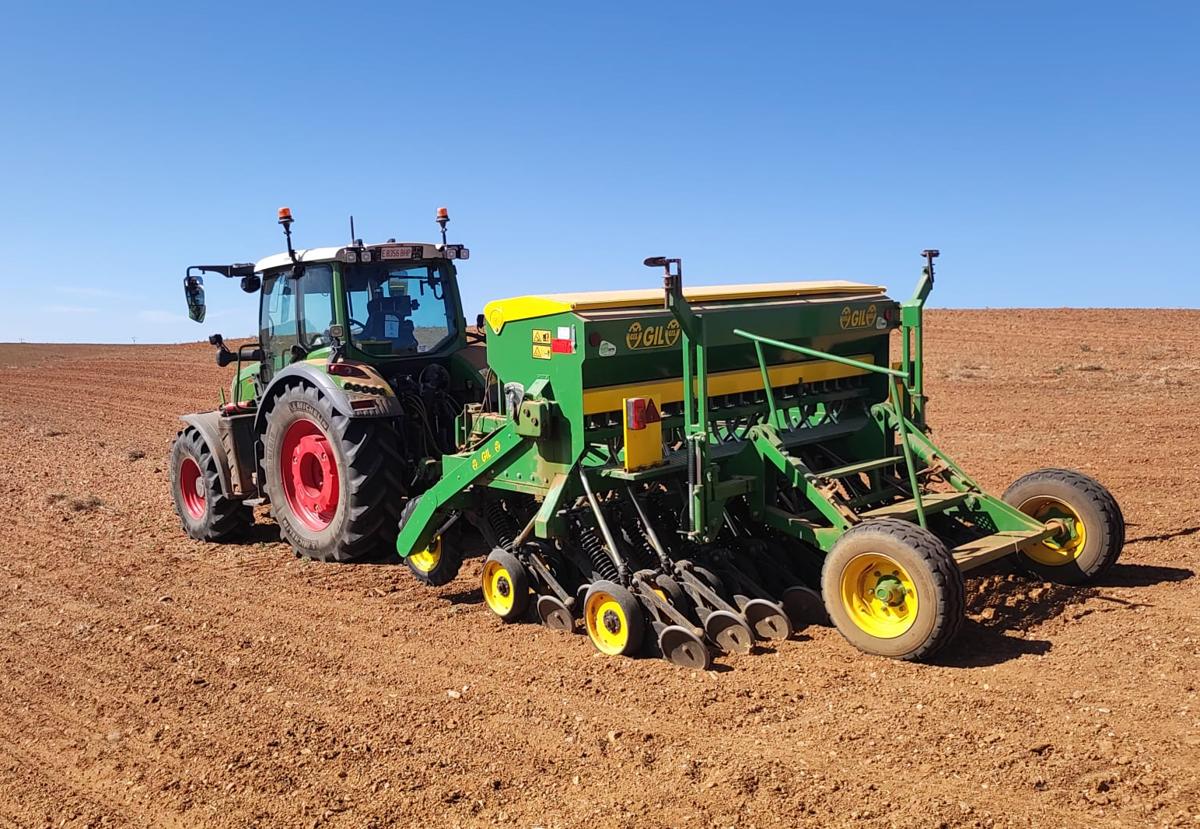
(170, 208, 485, 581)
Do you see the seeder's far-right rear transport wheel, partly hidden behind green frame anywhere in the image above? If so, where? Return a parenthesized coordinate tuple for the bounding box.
(1004, 469, 1124, 584)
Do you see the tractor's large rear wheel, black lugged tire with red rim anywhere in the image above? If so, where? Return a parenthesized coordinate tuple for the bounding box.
(263, 385, 401, 561)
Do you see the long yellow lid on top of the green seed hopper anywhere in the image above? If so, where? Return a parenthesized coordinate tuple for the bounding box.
(484, 280, 884, 334)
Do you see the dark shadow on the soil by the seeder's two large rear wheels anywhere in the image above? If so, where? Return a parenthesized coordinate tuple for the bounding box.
(932, 563, 1195, 668)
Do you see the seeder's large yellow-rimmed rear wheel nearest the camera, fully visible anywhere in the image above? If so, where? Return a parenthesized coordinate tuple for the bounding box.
(821, 518, 965, 660)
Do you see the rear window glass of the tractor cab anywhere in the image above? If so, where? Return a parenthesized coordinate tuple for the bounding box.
(346, 263, 456, 355)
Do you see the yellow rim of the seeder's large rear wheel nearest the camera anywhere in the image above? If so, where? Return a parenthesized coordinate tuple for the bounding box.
(841, 553, 917, 639)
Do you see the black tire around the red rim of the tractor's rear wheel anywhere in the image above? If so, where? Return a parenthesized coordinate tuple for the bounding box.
(263, 385, 401, 561)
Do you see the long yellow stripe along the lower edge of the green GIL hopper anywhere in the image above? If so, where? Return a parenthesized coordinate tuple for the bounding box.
(583, 354, 875, 414)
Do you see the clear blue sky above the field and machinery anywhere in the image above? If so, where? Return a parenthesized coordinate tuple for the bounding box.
(0, 2, 1200, 342)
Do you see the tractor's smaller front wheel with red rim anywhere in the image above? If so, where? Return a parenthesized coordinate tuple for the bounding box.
(170, 426, 254, 541)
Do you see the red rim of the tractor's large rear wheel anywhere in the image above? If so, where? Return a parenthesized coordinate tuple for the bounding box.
(280, 420, 341, 531)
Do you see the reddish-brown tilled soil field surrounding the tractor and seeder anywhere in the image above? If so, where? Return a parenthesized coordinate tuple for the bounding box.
(0, 311, 1200, 828)
